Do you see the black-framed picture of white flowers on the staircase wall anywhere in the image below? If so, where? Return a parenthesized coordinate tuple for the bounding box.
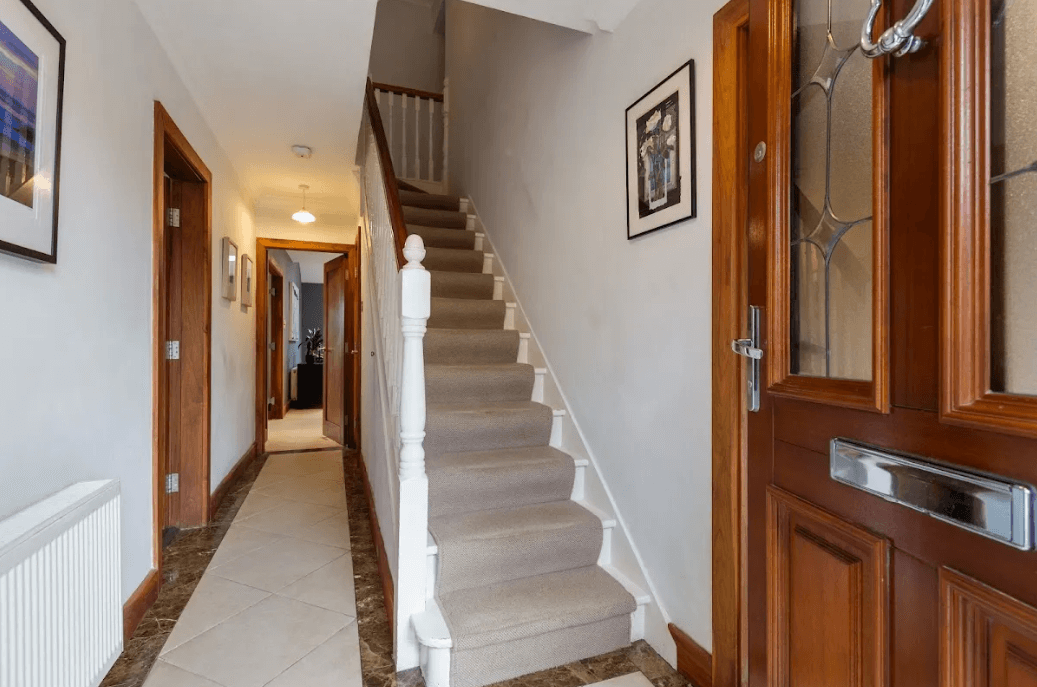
(626, 60, 695, 239)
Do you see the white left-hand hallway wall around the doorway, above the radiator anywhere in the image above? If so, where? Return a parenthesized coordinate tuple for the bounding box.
(0, 0, 255, 598)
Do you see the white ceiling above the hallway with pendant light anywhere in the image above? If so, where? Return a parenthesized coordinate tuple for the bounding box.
(137, 0, 377, 225)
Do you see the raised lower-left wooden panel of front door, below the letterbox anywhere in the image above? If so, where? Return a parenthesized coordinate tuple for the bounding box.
(767, 487, 889, 687)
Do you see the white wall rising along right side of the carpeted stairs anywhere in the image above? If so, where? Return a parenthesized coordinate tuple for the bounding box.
(447, 0, 722, 653)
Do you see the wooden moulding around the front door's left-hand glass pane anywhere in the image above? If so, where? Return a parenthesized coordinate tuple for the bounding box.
(763, 0, 890, 413)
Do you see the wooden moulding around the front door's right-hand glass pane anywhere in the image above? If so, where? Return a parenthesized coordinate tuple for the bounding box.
(940, 0, 1037, 437)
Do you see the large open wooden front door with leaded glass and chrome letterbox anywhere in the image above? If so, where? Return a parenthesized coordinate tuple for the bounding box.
(738, 0, 1037, 687)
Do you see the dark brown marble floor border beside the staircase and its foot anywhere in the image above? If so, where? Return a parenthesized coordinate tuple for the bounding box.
(342, 451, 691, 687)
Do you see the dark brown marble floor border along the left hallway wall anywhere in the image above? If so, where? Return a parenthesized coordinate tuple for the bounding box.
(101, 454, 267, 687)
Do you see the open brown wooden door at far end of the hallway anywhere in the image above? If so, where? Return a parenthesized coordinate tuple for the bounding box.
(324, 255, 352, 445)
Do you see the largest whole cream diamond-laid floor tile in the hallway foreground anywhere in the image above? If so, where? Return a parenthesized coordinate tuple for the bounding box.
(165, 596, 353, 687)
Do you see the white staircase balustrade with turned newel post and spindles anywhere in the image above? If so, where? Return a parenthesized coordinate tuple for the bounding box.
(360, 102, 431, 670)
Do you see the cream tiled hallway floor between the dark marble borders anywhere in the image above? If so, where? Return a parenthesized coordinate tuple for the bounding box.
(144, 450, 363, 687)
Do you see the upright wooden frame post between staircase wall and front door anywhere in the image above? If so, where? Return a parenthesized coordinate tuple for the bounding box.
(712, 0, 749, 687)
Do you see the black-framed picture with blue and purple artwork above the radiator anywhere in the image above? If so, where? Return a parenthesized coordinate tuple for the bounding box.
(0, 0, 65, 264)
